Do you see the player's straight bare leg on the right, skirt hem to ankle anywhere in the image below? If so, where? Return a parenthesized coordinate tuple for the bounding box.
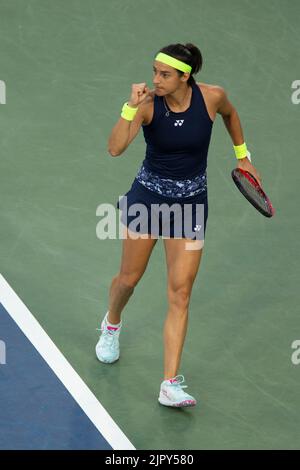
(164, 238, 203, 380)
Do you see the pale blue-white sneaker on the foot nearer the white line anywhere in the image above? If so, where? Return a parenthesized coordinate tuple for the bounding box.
(96, 312, 122, 364)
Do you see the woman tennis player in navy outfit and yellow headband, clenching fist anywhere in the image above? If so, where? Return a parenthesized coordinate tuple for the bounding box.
(96, 43, 260, 407)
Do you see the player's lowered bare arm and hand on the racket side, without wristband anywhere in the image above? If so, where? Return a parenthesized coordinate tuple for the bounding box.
(213, 86, 262, 185)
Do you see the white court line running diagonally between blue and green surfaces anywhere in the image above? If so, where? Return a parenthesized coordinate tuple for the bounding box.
(0, 274, 135, 450)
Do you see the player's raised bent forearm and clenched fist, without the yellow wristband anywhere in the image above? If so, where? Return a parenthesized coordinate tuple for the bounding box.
(108, 83, 150, 157)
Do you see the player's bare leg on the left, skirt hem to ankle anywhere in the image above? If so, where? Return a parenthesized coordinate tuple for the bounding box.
(108, 228, 157, 324)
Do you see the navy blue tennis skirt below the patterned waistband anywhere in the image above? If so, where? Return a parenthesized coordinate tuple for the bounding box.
(117, 179, 208, 240)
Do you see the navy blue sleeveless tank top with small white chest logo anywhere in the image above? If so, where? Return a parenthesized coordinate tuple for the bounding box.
(142, 83, 213, 180)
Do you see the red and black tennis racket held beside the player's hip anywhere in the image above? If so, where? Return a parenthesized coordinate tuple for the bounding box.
(231, 168, 275, 217)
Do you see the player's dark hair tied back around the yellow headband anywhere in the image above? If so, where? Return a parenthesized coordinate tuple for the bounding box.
(158, 42, 203, 85)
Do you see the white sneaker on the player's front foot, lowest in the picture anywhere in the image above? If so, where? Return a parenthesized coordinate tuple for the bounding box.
(158, 375, 197, 408)
